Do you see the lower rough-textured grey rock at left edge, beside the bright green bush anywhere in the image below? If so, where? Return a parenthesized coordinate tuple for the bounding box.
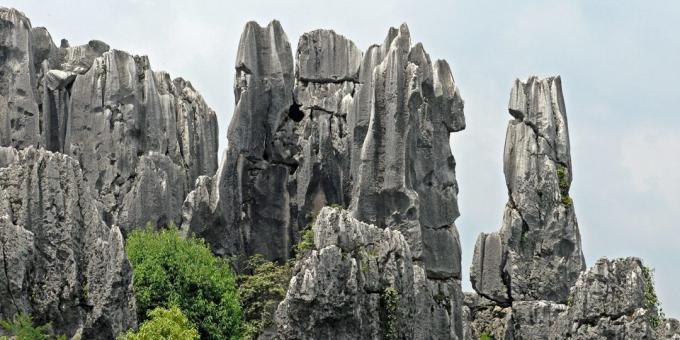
(0, 147, 137, 339)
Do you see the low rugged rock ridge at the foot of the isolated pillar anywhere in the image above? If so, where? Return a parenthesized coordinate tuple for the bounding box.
(464, 257, 680, 340)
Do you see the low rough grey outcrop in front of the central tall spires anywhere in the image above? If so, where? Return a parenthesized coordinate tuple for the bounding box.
(276, 208, 418, 339)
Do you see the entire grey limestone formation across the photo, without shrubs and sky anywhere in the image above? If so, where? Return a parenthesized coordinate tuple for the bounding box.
(0, 8, 680, 339)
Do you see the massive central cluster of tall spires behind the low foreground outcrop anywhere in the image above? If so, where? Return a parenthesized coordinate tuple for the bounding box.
(183, 21, 465, 338)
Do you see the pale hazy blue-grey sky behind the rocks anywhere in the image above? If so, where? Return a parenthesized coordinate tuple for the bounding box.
(4, 0, 680, 317)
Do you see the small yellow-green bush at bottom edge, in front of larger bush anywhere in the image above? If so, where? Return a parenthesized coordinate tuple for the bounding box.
(118, 306, 200, 340)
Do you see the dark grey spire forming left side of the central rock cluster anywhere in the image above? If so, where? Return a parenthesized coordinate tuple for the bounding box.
(183, 21, 297, 259)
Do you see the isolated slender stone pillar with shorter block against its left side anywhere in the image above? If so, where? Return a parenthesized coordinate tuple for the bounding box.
(470, 77, 585, 305)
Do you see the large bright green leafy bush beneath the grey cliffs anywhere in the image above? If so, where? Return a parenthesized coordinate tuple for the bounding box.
(125, 227, 242, 339)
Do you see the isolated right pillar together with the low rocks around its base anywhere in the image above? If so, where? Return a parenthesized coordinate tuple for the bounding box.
(463, 77, 677, 339)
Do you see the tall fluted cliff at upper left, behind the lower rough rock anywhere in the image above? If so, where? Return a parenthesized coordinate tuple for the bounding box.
(0, 8, 217, 230)
